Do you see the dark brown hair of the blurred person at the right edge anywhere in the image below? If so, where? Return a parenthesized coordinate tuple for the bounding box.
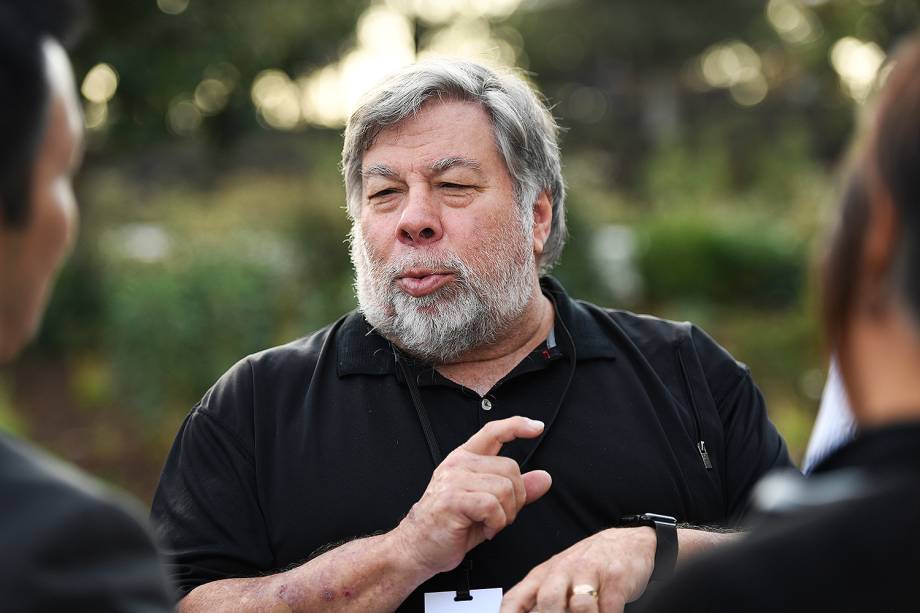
(823, 33, 920, 352)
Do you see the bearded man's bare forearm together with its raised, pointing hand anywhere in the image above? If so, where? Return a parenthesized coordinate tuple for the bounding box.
(179, 416, 552, 613)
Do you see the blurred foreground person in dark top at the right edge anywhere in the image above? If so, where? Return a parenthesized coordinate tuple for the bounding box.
(643, 35, 920, 612)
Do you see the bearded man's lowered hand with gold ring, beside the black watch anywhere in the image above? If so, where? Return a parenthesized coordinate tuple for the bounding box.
(501, 527, 656, 613)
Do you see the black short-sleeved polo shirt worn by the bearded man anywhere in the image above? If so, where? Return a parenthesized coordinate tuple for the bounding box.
(152, 278, 790, 611)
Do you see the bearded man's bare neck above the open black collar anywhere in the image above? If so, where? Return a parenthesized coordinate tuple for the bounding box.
(435, 286, 555, 396)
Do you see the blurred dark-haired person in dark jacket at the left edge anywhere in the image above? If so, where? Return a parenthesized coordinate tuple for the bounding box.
(0, 0, 170, 613)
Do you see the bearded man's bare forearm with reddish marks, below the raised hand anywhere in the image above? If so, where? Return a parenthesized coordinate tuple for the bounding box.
(179, 533, 428, 613)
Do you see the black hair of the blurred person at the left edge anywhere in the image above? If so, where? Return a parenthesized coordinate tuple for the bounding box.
(0, 0, 83, 226)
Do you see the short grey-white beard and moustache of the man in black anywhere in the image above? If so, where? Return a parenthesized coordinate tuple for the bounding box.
(351, 210, 536, 364)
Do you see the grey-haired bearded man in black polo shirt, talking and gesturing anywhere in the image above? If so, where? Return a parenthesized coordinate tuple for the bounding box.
(153, 61, 789, 612)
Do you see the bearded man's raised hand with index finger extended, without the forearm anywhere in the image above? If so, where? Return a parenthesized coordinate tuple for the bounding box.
(391, 417, 552, 575)
